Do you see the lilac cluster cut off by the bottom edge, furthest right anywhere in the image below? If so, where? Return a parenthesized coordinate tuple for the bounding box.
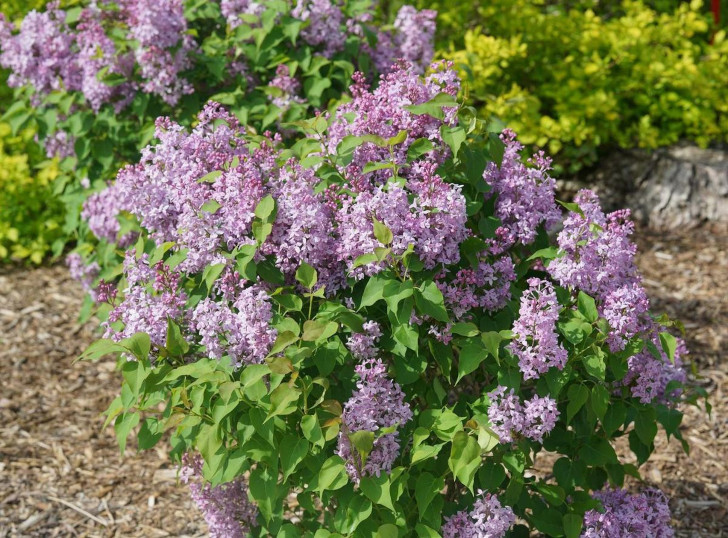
(581, 488, 675, 538)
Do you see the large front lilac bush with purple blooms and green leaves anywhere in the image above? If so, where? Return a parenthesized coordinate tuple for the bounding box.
(79, 62, 696, 537)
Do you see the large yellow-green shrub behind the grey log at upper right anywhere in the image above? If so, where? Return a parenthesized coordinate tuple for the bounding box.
(423, 0, 728, 171)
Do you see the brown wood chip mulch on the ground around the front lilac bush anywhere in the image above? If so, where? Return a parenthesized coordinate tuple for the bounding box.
(0, 223, 728, 538)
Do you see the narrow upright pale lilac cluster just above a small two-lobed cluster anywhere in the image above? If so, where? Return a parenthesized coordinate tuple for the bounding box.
(509, 278, 569, 379)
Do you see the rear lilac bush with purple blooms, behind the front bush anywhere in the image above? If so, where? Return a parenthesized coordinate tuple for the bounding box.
(0, 0, 435, 258)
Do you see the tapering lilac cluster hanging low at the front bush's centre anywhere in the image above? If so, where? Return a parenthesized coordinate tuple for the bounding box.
(337, 359, 412, 484)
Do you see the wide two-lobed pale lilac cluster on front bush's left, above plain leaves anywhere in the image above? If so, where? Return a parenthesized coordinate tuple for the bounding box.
(191, 285, 278, 368)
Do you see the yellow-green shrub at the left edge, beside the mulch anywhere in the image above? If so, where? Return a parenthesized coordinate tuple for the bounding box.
(0, 123, 63, 263)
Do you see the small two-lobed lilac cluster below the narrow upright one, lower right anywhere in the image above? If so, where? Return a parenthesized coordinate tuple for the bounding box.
(488, 386, 559, 443)
